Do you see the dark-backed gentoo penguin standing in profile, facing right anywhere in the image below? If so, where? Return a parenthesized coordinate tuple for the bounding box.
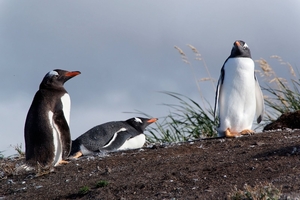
(25, 69, 80, 167)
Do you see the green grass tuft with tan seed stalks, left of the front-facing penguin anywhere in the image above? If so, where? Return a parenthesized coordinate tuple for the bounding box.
(140, 44, 218, 143)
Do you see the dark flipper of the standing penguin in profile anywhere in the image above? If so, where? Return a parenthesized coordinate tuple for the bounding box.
(53, 110, 72, 159)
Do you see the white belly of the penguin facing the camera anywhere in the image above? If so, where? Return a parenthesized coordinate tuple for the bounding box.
(218, 58, 256, 132)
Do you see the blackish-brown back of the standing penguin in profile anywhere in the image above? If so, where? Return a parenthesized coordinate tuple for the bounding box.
(25, 89, 65, 165)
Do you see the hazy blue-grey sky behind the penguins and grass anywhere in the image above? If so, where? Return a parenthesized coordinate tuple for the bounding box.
(0, 0, 300, 156)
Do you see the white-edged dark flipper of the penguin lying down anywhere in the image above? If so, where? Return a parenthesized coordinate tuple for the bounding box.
(99, 128, 131, 151)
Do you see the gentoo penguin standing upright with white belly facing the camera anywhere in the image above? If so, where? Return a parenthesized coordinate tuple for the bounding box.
(214, 40, 264, 137)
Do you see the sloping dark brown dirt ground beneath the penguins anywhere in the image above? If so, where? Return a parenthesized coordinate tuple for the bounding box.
(0, 130, 300, 200)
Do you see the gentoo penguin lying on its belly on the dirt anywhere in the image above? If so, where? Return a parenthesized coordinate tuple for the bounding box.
(70, 117, 157, 158)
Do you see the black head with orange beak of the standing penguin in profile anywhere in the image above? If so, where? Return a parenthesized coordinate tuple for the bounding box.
(40, 69, 81, 89)
